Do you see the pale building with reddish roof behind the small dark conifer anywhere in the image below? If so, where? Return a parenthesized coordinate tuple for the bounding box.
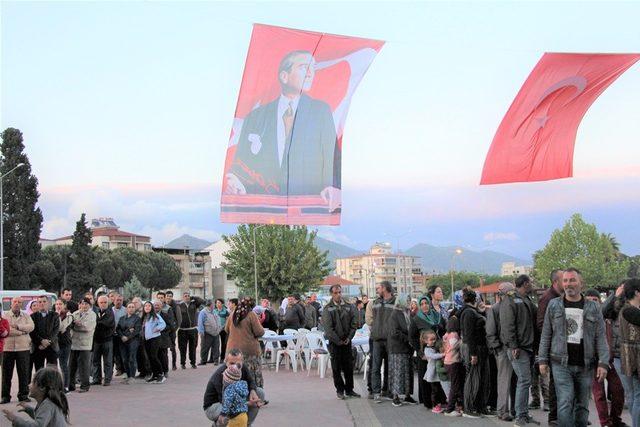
(40, 218, 151, 251)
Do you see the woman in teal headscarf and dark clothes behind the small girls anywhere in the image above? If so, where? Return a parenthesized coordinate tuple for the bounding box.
(409, 295, 446, 409)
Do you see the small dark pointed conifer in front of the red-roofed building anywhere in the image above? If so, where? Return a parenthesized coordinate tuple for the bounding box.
(66, 213, 100, 295)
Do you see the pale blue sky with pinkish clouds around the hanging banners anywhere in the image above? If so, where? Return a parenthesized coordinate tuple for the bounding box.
(0, 1, 640, 258)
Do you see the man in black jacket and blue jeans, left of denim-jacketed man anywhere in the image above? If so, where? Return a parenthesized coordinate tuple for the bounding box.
(500, 274, 540, 427)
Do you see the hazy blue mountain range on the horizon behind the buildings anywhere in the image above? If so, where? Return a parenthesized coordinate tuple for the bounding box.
(315, 237, 532, 274)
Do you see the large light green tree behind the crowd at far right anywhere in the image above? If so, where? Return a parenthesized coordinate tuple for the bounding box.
(533, 214, 630, 287)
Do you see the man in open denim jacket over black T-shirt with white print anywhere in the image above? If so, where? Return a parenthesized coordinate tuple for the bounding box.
(538, 268, 609, 427)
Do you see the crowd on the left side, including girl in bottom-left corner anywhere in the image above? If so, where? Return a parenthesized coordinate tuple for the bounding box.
(0, 289, 276, 426)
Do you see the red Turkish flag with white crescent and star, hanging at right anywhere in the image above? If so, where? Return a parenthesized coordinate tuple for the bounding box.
(480, 53, 640, 185)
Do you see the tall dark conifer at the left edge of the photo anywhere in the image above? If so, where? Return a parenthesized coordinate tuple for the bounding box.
(0, 128, 42, 289)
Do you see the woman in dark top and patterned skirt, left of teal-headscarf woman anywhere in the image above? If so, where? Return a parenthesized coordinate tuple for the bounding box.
(387, 294, 417, 406)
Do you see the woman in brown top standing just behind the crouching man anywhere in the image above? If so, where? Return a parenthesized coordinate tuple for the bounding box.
(225, 297, 264, 387)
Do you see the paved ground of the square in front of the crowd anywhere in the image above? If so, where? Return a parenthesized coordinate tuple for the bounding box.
(0, 365, 631, 427)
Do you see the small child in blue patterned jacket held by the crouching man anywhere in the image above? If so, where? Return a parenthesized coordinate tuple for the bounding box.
(220, 365, 249, 427)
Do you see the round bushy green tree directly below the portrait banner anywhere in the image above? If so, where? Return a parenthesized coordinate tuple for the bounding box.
(222, 225, 330, 300)
